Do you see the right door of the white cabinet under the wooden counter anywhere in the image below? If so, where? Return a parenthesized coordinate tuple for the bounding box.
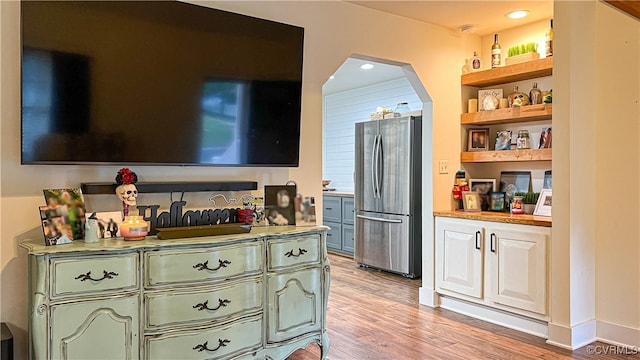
(487, 228, 547, 315)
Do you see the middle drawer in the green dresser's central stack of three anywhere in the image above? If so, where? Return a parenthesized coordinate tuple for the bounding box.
(144, 278, 263, 329)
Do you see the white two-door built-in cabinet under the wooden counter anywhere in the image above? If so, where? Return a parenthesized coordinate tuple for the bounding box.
(435, 217, 551, 319)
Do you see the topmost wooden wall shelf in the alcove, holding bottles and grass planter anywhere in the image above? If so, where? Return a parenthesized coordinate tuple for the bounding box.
(461, 57, 553, 87)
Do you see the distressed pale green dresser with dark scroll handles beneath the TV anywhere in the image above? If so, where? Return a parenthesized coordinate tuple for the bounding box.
(21, 226, 329, 359)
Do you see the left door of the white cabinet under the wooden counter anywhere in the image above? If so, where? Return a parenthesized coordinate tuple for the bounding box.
(436, 218, 484, 298)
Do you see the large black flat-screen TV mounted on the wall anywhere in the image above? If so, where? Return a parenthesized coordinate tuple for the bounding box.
(21, 1, 304, 167)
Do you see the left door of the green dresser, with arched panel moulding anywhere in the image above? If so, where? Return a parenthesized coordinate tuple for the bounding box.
(50, 296, 140, 360)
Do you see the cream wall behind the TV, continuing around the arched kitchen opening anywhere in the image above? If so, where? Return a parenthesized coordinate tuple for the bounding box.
(0, 1, 468, 359)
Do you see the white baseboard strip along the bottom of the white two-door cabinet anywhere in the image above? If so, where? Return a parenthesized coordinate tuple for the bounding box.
(440, 296, 549, 339)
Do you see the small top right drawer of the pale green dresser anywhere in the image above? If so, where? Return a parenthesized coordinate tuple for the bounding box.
(267, 234, 320, 270)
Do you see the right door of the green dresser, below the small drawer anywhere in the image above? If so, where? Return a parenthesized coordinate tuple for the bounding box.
(267, 268, 324, 343)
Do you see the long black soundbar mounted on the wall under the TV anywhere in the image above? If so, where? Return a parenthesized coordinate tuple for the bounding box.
(81, 181, 258, 195)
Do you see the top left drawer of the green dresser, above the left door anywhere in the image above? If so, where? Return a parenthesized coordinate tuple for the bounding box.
(51, 253, 138, 298)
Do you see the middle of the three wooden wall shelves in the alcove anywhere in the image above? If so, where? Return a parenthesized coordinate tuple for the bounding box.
(460, 104, 553, 125)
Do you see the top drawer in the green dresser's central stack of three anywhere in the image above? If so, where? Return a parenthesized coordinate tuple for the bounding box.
(144, 241, 263, 286)
